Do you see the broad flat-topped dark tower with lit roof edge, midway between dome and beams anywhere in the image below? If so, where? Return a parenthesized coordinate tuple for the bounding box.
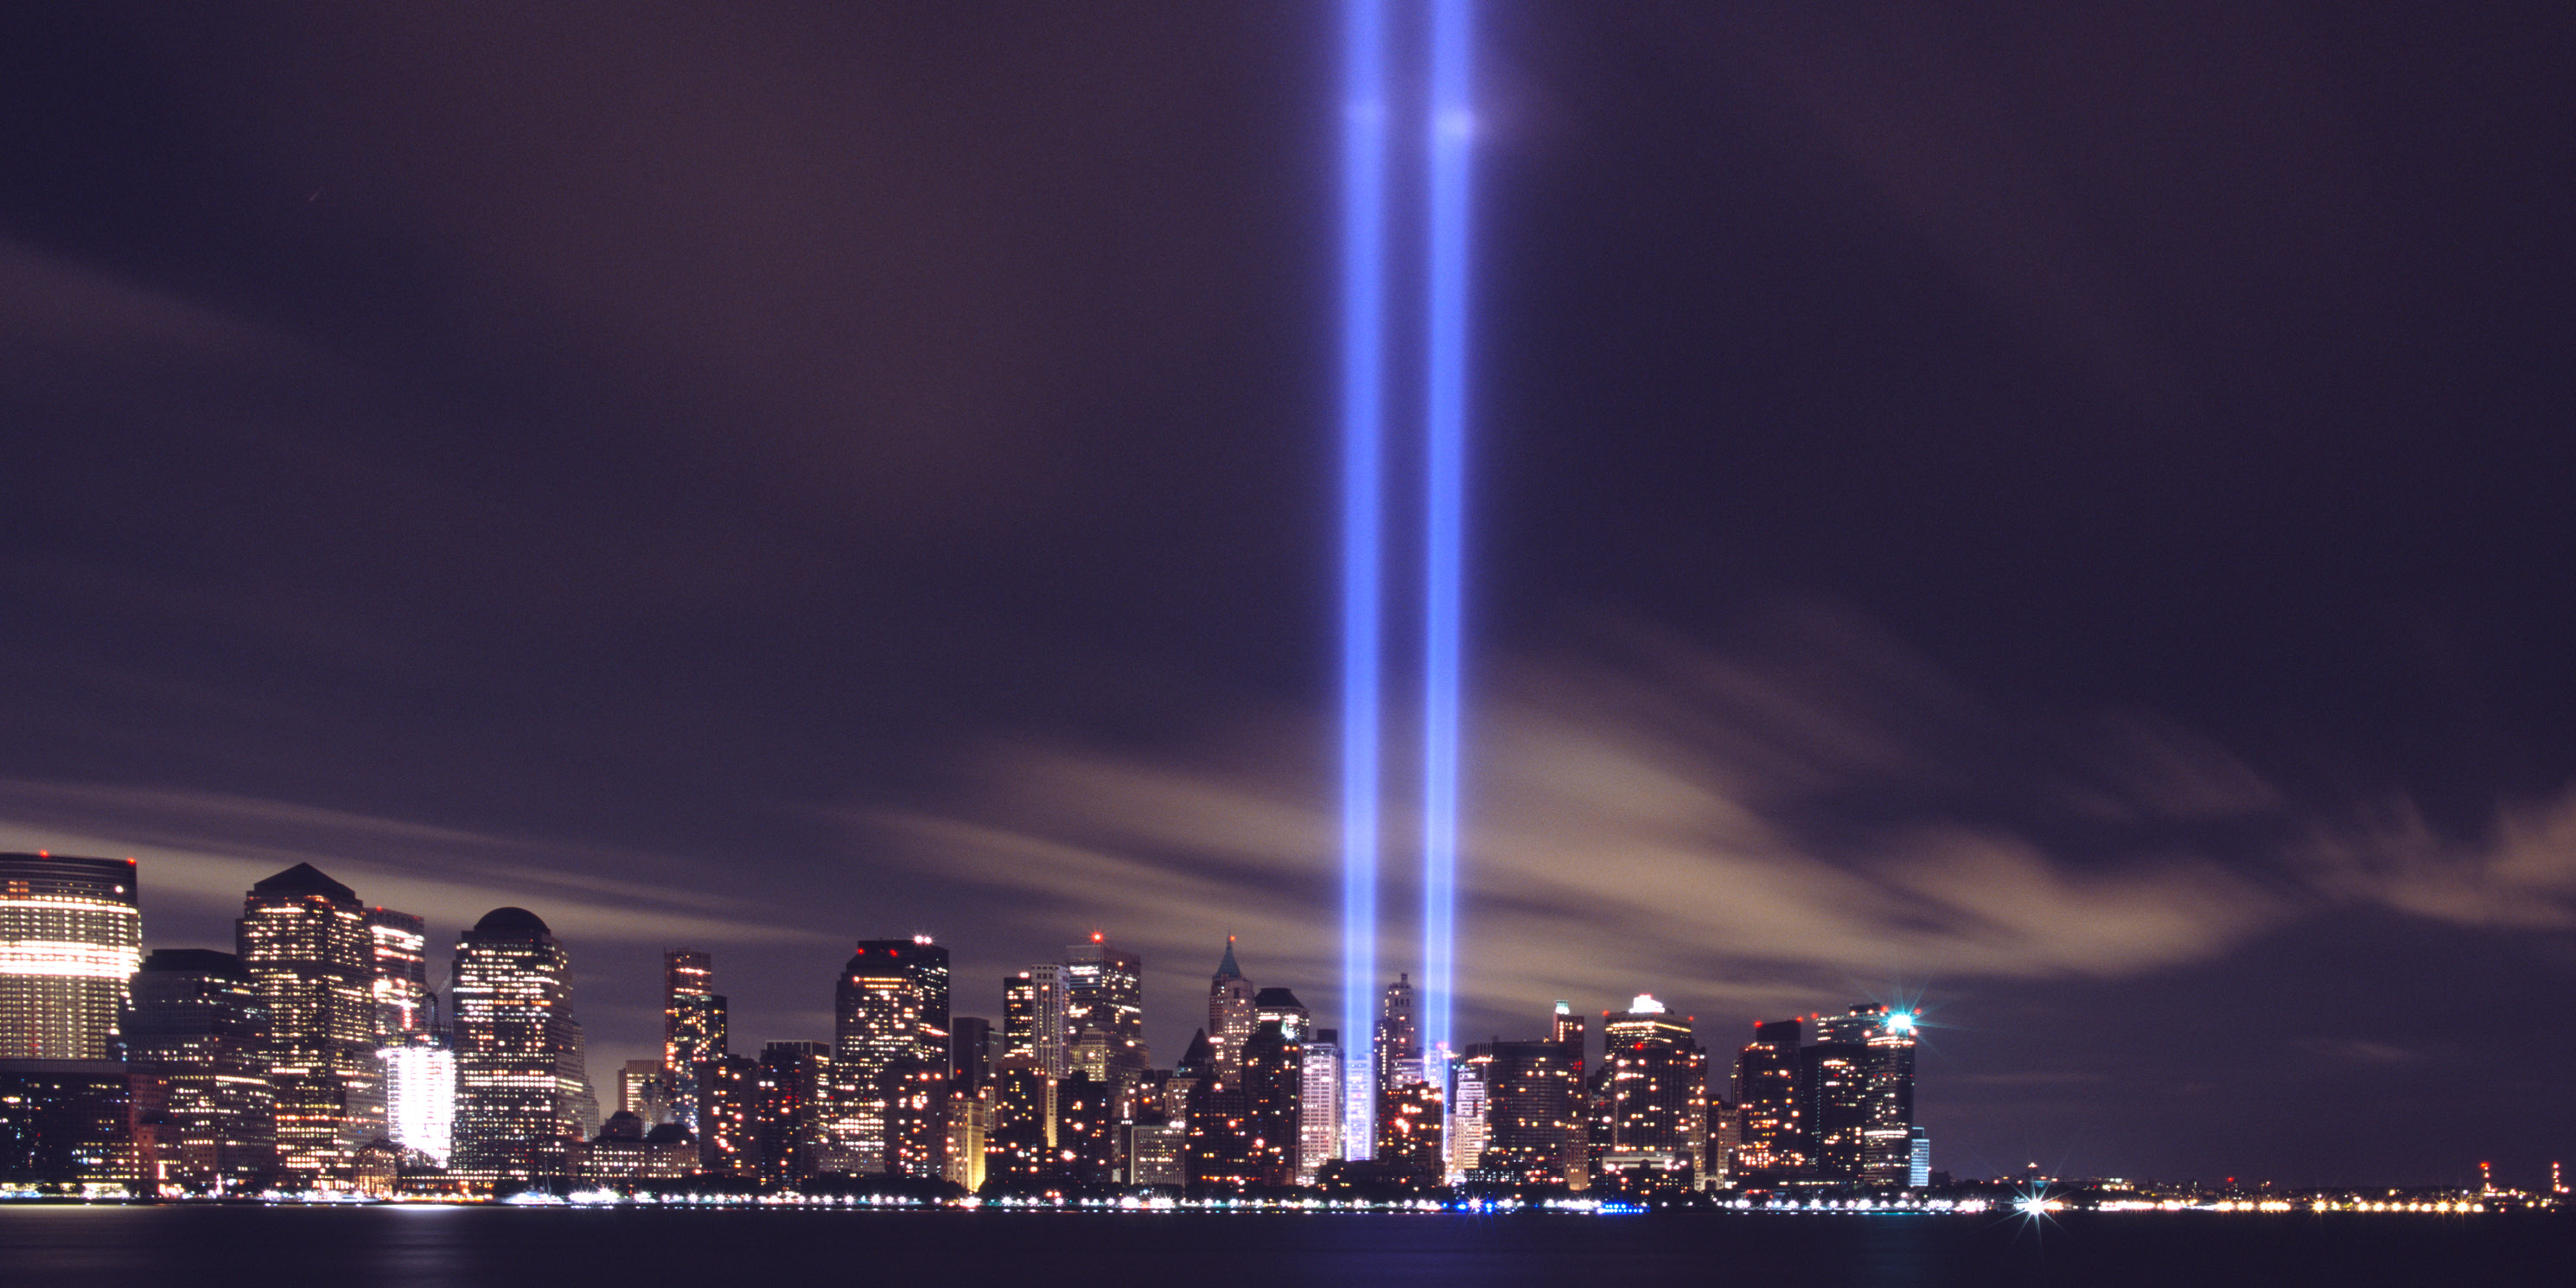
(832, 935, 948, 1180)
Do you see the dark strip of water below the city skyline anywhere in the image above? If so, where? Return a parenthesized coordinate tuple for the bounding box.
(0, 1203, 2576, 1288)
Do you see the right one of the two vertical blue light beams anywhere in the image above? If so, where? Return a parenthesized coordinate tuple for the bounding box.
(1422, 0, 1474, 1087)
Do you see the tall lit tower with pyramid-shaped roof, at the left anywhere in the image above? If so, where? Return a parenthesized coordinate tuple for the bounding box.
(234, 863, 384, 1188)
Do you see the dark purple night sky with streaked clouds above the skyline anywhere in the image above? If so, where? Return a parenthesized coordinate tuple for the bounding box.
(0, 0, 2576, 1185)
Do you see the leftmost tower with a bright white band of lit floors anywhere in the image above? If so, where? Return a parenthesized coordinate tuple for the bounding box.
(0, 852, 144, 1062)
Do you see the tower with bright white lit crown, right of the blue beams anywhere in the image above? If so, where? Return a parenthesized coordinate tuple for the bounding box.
(1592, 994, 1708, 1193)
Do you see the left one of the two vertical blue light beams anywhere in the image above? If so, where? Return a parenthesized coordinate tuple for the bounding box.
(1342, 0, 1386, 1159)
